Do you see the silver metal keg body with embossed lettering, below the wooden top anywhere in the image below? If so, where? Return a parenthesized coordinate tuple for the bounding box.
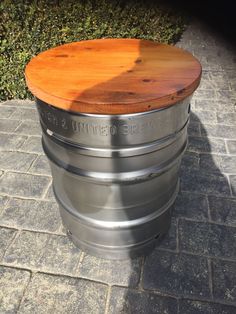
(37, 97, 191, 259)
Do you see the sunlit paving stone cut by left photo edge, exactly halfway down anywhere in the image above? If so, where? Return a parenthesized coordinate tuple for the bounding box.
(0, 151, 37, 172)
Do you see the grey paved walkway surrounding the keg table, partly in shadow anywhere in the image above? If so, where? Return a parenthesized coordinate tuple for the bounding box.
(0, 23, 236, 314)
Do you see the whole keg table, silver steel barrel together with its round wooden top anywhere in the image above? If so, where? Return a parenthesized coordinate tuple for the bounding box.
(25, 38, 201, 259)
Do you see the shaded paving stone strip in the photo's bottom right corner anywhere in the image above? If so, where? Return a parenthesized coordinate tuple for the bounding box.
(179, 300, 236, 314)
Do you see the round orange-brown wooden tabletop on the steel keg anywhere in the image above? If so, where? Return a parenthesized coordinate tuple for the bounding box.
(25, 39, 201, 114)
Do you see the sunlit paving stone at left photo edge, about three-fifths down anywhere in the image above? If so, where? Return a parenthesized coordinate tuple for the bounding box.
(0, 172, 50, 198)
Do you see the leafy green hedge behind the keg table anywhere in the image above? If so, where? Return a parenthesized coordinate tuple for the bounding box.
(0, 0, 188, 100)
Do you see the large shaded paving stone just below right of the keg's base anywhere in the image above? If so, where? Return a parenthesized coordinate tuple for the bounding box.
(143, 250, 210, 297)
